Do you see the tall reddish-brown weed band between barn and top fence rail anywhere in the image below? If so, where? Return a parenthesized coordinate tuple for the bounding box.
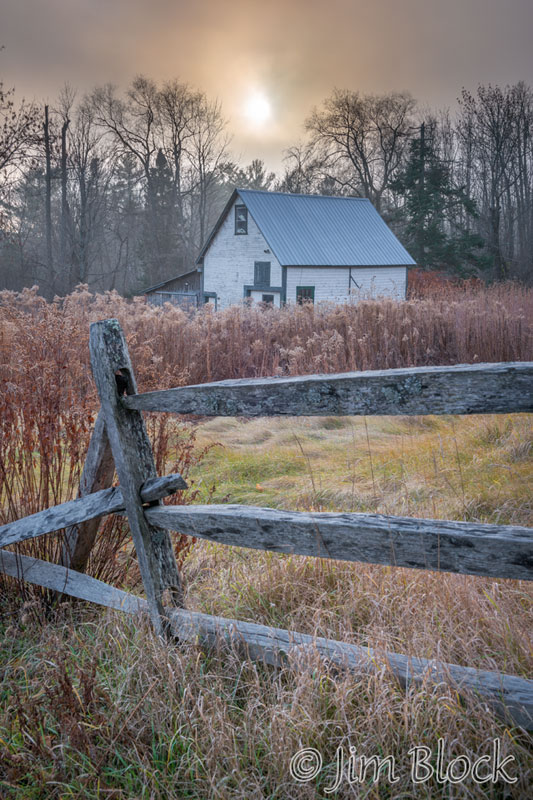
(0, 283, 533, 396)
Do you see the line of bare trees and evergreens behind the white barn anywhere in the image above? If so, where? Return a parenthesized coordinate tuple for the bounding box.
(0, 76, 533, 297)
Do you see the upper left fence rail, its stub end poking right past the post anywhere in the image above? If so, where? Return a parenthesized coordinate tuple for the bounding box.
(0, 473, 187, 552)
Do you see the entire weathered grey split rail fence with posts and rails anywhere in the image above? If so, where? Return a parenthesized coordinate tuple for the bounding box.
(0, 320, 533, 730)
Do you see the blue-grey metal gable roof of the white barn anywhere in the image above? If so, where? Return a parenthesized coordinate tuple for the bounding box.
(195, 189, 415, 267)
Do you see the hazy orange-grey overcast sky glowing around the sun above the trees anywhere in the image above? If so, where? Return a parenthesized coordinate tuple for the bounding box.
(0, 0, 533, 169)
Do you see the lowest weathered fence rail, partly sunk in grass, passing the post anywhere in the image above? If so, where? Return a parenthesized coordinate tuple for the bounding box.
(0, 550, 533, 730)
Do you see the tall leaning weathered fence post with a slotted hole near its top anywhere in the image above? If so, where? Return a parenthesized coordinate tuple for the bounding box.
(90, 319, 183, 634)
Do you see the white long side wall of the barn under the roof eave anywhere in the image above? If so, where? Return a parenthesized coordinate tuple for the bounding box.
(287, 267, 407, 303)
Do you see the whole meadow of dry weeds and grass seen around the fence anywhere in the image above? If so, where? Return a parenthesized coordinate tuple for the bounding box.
(0, 284, 533, 800)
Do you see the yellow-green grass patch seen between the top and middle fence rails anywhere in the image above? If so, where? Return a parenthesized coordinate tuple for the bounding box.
(192, 414, 533, 525)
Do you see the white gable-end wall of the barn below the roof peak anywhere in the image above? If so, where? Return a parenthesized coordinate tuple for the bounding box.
(204, 199, 281, 308)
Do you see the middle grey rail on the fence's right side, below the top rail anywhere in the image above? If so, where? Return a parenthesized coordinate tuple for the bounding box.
(145, 505, 533, 580)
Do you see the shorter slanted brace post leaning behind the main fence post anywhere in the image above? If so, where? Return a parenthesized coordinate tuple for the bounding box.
(61, 411, 115, 572)
